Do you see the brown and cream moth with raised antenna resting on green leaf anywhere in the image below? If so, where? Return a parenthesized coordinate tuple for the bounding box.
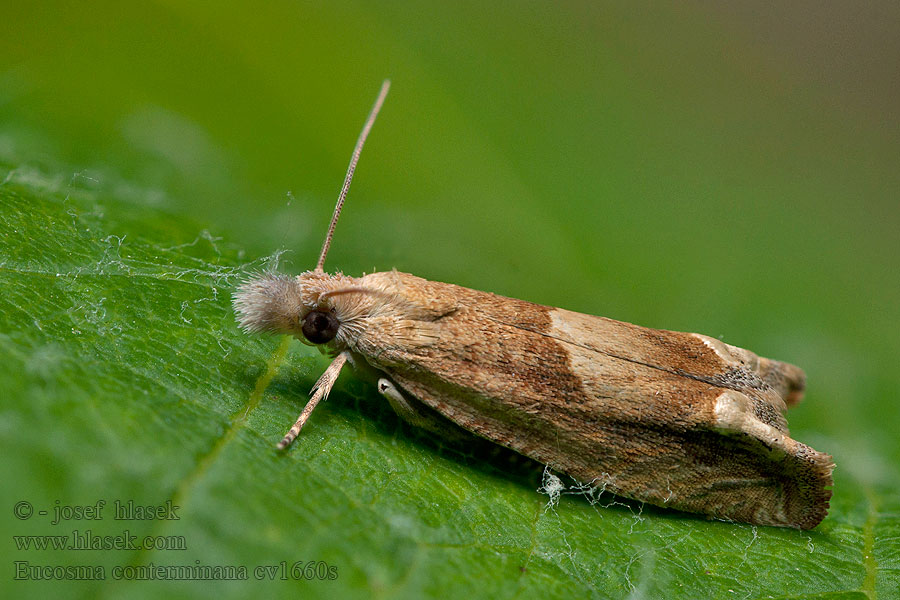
(234, 81, 834, 529)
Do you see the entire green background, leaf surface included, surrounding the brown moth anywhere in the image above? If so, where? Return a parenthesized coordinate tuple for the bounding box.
(0, 1, 900, 598)
